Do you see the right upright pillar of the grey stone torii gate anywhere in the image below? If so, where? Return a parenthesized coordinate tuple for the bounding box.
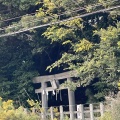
(67, 78, 75, 120)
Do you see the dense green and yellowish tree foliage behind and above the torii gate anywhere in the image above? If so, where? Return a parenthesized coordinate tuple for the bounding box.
(0, 0, 120, 101)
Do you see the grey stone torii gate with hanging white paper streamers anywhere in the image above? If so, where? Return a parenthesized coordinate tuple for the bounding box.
(33, 71, 76, 120)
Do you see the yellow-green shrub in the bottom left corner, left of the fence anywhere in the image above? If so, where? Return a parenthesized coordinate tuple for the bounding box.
(0, 97, 40, 120)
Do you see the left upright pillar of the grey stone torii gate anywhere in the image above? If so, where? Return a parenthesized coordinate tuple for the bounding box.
(41, 82, 48, 119)
